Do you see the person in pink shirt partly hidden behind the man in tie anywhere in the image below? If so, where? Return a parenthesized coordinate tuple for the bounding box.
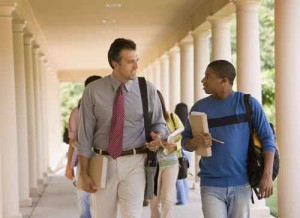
(65, 75, 101, 218)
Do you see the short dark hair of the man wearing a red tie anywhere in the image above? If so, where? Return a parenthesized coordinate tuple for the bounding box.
(108, 38, 136, 69)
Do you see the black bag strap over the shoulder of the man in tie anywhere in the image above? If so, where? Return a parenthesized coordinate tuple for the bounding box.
(138, 77, 157, 166)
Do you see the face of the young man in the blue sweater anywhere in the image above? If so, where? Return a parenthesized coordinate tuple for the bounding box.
(201, 67, 222, 95)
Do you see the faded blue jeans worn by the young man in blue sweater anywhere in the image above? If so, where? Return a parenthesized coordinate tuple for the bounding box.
(201, 184, 251, 218)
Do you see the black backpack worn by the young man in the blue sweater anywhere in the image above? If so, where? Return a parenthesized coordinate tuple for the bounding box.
(244, 94, 279, 197)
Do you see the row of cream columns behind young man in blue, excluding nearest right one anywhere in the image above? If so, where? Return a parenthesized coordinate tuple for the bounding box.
(144, 0, 269, 216)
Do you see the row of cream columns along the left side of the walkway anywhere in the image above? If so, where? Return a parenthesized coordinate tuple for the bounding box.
(0, 1, 61, 217)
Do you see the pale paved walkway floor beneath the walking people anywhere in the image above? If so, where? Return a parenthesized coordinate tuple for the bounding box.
(21, 173, 203, 218)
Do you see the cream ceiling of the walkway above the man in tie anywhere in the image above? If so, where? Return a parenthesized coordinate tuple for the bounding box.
(28, 0, 228, 71)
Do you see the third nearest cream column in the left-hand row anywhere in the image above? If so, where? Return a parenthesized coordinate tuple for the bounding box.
(24, 34, 38, 195)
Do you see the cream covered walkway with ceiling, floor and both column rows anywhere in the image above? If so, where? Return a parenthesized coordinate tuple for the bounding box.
(0, 0, 300, 218)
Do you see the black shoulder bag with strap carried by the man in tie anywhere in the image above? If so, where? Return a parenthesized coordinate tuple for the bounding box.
(138, 77, 157, 200)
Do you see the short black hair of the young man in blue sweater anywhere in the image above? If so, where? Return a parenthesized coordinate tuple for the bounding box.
(207, 60, 236, 85)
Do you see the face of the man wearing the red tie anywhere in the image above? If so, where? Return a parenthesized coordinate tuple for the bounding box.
(114, 49, 138, 82)
